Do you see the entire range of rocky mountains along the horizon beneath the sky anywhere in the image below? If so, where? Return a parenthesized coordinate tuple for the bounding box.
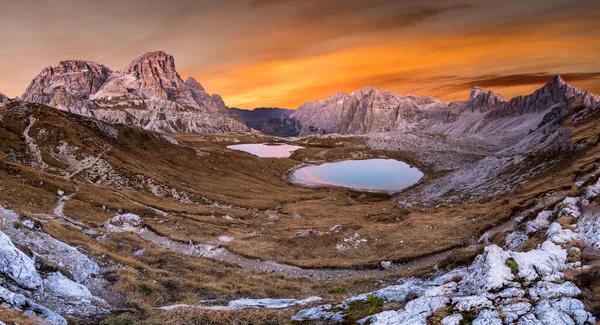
(8, 51, 600, 144)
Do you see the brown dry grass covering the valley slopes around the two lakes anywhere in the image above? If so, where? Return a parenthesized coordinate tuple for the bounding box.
(5, 102, 600, 324)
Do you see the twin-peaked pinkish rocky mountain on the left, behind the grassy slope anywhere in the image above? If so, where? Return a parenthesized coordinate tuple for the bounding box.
(22, 51, 248, 133)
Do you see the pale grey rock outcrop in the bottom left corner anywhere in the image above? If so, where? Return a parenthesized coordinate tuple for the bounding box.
(0, 206, 111, 325)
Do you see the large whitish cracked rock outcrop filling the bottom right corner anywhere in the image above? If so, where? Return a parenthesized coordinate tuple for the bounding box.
(292, 178, 600, 325)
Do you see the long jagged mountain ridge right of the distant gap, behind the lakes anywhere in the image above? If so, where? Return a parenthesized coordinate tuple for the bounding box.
(293, 76, 600, 136)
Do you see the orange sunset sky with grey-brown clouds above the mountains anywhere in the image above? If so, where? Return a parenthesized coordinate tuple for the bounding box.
(0, 0, 600, 109)
